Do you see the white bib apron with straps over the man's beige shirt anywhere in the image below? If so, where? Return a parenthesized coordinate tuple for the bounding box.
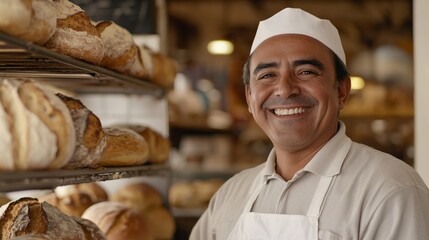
(228, 174, 333, 240)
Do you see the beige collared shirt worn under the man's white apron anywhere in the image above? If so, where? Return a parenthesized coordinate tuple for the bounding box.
(190, 123, 429, 240)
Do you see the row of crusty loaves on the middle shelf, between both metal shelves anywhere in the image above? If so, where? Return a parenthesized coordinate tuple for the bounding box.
(0, 79, 170, 171)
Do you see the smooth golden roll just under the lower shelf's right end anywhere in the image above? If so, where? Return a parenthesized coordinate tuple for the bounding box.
(110, 182, 162, 212)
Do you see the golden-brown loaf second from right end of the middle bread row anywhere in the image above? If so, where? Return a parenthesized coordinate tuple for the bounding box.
(98, 128, 149, 166)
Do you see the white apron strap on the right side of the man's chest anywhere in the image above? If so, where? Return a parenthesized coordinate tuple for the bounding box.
(307, 176, 334, 218)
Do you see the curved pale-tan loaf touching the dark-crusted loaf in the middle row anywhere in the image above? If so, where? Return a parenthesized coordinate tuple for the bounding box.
(18, 81, 76, 169)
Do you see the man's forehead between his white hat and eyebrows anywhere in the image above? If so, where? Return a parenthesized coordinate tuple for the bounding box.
(250, 34, 333, 65)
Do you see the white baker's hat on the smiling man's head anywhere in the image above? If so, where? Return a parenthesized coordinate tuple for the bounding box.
(250, 8, 346, 65)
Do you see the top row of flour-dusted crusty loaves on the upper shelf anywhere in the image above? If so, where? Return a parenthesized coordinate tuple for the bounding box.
(0, 0, 177, 88)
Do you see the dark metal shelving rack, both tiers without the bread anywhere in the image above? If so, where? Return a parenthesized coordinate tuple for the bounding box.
(0, 32, 171, 192)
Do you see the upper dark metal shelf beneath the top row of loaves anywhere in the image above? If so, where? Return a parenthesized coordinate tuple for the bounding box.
(0, 32, 166, 97)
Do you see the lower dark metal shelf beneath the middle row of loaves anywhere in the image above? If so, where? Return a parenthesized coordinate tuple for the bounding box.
(0, 165, 171, 192)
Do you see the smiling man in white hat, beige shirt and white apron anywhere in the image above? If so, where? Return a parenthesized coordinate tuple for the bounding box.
(190, 8, 429, 240)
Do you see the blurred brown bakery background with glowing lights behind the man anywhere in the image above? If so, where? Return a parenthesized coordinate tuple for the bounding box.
(67, 0, 415, 239)
